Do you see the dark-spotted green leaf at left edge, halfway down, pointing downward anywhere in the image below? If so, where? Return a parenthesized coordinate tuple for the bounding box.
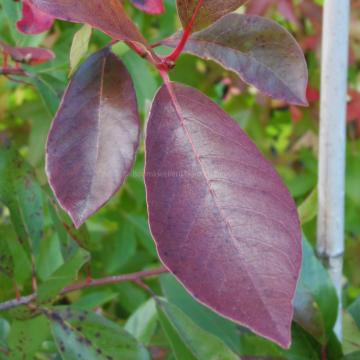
(0, 144, 44, 257)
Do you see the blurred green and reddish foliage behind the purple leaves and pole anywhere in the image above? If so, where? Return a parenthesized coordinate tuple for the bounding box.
(0, 0, 360, 360)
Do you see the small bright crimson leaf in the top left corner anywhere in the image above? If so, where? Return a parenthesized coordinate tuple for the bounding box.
(16, 0, 54, 35)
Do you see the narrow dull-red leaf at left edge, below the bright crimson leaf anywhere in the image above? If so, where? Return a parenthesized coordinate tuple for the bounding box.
(0, 40, 55, 65)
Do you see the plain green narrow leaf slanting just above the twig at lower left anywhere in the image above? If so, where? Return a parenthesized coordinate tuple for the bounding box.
(37, 248, 90, 303)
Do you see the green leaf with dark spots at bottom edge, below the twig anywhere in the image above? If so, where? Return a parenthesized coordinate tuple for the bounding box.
(45, 308, 149, 360)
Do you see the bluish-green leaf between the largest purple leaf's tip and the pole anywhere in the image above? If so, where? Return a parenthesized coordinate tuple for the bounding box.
(294, 238, 338, 344)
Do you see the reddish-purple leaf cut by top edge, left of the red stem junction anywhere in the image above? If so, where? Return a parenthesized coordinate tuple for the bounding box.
(31, 0, 145, 43)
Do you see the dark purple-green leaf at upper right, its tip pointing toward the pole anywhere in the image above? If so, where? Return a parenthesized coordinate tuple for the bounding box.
(164, 14, 308, 105)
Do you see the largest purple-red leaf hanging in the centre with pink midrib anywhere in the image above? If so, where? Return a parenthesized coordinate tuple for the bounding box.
(145, 84, 301, 347)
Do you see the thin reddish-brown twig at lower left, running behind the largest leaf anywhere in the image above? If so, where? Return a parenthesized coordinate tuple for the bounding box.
(0, 267, 168, 311)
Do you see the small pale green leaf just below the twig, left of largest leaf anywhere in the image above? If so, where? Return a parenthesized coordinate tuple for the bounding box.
(125, 299, 157, 345)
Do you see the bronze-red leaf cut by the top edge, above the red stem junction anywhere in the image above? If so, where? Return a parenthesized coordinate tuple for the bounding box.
(177, 0, 246, 31)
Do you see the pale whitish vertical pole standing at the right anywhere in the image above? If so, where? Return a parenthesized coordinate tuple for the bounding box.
(317, 0, 350, 340)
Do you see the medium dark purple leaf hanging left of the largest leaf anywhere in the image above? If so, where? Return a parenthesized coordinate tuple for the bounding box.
(46, 50, 139, 227)
